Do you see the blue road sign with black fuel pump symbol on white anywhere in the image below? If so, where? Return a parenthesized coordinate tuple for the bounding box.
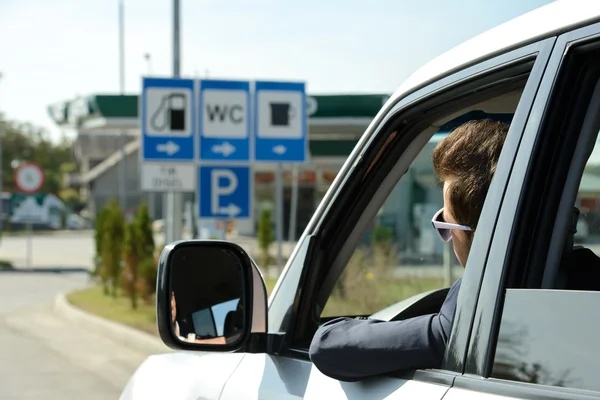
(141, 78, 196, 161)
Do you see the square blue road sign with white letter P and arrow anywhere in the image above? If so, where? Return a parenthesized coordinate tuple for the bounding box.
(198, 165, 252, 219)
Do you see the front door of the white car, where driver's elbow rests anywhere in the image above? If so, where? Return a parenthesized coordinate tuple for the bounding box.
(221, 38, 554, 399)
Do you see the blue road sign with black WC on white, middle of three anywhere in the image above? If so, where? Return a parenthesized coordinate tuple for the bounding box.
(198, 80, 250, 161)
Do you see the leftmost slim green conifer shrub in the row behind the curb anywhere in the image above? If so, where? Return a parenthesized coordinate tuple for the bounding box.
(101, 199, 125, 298)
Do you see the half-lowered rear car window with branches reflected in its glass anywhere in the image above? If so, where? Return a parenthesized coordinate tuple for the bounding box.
(492, 136, 600, 391)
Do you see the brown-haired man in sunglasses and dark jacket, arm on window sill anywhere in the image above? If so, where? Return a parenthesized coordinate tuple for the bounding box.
(309, 119, 508, 381)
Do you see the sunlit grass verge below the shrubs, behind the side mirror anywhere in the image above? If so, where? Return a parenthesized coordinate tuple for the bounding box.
(67, 278, 277, 335)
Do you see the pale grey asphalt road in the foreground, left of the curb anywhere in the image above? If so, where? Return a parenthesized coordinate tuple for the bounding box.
(0, 270, 152, 399)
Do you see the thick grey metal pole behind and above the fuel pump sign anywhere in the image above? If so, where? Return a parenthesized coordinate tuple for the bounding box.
(165, 0, 183, 243)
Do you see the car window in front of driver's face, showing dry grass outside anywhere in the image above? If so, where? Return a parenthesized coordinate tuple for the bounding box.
(321, 103, 522, 319)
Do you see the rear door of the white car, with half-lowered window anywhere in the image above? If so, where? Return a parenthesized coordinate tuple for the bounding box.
(444, 23, 600, 400)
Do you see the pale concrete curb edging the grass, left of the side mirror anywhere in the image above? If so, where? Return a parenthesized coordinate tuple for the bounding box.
(54, 293, 173, 356)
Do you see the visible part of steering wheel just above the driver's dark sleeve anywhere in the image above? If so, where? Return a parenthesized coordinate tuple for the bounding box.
(369, 288, 450, 321)
